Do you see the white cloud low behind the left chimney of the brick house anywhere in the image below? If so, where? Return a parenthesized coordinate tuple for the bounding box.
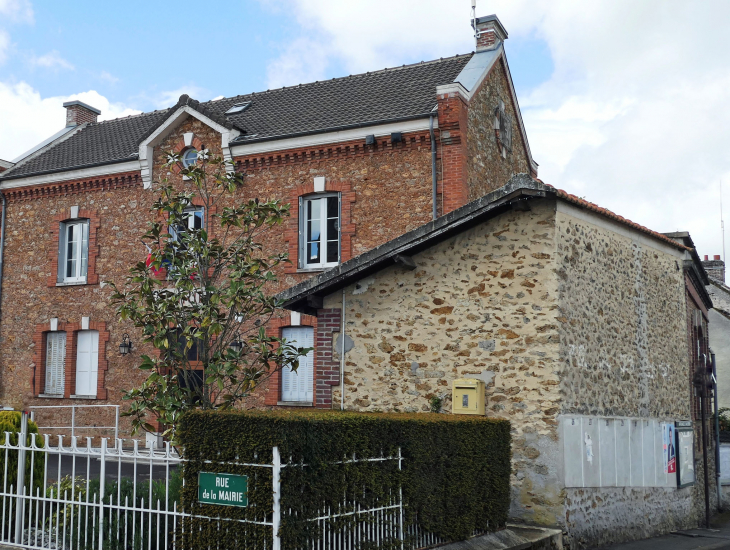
(0, 82, 140, 160)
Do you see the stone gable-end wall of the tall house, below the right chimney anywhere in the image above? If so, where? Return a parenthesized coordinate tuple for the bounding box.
(467, 60, 530, 201)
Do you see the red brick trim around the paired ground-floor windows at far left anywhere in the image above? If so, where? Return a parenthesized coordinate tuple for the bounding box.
(31, 321, 110, 399)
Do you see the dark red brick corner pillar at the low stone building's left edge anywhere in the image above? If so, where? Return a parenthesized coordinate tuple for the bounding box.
(314, 309, 342, 409)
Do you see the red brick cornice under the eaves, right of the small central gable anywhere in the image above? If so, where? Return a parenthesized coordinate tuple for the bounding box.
(234, 131, 431, 172)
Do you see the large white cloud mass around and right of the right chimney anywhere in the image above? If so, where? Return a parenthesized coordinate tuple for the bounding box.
(260, 0, 730, 268)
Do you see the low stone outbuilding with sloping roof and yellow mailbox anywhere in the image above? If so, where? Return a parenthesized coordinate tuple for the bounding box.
(279, 174, 716, 548)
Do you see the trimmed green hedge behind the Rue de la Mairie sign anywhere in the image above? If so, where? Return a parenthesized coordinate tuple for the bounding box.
(179, 411, 511, 548)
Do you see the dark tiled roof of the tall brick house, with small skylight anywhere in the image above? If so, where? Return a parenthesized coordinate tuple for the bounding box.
(0, 54, 473, 179)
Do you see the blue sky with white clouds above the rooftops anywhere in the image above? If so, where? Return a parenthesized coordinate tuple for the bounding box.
(0, 0, 730, 270)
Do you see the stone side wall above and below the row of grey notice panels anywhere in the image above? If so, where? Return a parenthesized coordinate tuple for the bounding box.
(555, 205, 704, 548)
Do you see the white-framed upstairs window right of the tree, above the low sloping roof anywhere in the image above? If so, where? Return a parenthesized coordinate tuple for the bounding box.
(299, 194, 340, 269)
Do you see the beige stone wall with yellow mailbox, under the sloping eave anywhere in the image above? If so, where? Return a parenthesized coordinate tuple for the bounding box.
(324, 202, 562, 524)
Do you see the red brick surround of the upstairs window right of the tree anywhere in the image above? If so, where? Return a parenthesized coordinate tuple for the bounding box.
(284, 178, 356, 273)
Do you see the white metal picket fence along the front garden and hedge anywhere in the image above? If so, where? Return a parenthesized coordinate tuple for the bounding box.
(0, 415, 458, 550)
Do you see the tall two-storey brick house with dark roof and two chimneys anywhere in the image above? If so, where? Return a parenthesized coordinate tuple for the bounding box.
(0, 16, 537, 432)
